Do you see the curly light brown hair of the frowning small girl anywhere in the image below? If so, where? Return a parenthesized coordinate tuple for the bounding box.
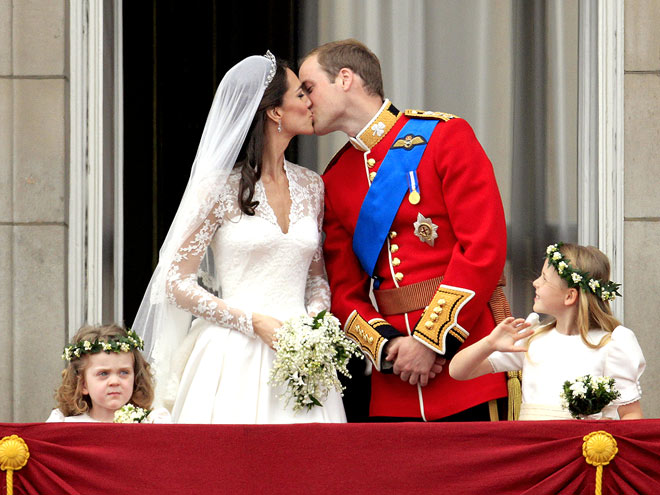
(55, 324, 154, 416)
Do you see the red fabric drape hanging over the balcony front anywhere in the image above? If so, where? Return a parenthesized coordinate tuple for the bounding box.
(0, 420, 660, 495)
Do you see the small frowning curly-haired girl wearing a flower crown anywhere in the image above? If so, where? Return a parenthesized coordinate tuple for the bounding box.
(46, 325, 171, 423)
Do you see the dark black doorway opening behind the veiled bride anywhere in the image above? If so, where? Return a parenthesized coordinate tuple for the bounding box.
(123, 0, 302, 325)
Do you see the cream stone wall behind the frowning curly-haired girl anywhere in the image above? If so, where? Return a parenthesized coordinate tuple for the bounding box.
(0, 0, 68, 422)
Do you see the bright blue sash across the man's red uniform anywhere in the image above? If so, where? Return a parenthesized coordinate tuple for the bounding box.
(353, 119, 438, 277)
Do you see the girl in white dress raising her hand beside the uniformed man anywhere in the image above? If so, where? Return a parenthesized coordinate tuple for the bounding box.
(449, 243, 646, 420)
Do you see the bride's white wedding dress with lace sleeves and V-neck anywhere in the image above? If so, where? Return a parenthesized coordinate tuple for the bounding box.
(167, 162, 346, 424)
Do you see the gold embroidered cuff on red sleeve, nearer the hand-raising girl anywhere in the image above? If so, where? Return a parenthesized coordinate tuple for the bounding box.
(413, 285, 474, 357)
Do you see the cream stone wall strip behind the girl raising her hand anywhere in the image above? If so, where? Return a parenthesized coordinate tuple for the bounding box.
(623, 0, 660, 418)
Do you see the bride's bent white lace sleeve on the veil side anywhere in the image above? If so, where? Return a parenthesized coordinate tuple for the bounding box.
(166, 201, 254, 337)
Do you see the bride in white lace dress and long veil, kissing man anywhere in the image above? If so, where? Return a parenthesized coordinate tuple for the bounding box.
(133, 52, 346, 423)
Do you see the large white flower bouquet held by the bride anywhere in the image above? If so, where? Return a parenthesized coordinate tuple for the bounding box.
(268, 311, 362, 411)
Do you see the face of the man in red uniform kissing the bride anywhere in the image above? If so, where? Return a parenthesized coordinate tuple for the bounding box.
(300, 55, 342, 136)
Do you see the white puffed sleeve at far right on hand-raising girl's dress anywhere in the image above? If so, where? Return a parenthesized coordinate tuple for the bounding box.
(605, 326, 646, 406)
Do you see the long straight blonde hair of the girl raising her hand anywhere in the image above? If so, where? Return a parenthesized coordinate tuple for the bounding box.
(529, 244, 621, 349)
